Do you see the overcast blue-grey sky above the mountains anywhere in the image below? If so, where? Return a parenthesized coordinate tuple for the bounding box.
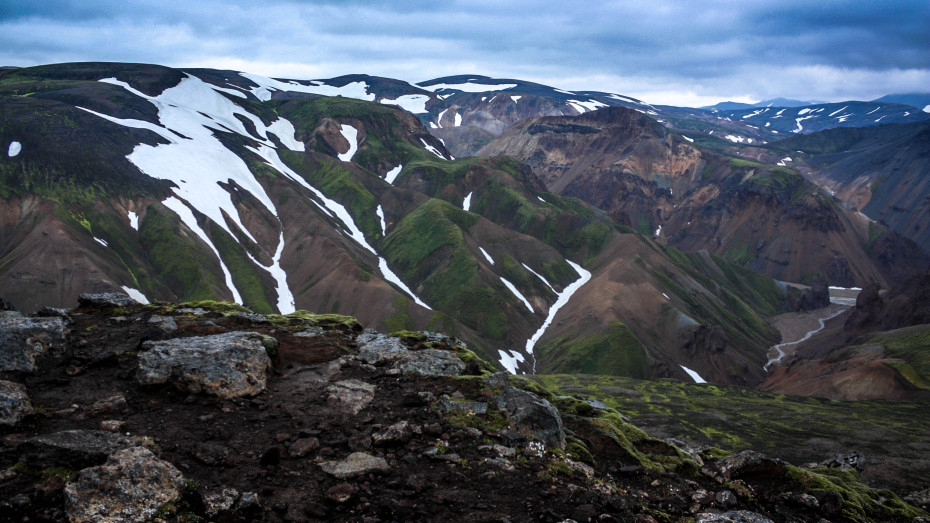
(0, 0, 930, 107)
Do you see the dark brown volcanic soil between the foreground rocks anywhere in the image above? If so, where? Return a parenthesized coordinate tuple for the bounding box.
(0, 298, 924, 522)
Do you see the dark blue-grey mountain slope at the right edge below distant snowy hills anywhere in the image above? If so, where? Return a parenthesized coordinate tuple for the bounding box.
(767, 122, 930, 255)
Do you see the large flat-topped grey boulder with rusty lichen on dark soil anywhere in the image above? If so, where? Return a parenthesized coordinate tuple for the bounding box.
(136, 332, 274, 399)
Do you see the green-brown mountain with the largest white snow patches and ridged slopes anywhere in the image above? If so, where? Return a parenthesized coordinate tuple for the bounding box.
(0, 63, 788, 385)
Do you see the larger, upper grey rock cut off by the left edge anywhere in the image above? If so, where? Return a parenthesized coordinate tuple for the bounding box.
(0, 314, 65, 372)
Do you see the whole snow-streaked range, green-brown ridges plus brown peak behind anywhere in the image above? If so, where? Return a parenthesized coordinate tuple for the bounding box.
(0, 63, 930, 385)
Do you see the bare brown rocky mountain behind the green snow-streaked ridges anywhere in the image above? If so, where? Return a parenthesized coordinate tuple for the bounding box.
(479, 108, 930, 287)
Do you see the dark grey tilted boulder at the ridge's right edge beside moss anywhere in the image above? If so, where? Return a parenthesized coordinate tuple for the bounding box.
(494, 387, 565, 449)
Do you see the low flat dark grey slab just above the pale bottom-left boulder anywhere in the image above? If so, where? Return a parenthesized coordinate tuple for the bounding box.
(16, 430, 136, 469)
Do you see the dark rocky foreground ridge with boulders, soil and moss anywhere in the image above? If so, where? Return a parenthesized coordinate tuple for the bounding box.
(0, 294, 930, 522)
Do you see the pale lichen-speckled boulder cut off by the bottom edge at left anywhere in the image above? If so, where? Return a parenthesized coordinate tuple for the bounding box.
(64, 447, 184, 523)
